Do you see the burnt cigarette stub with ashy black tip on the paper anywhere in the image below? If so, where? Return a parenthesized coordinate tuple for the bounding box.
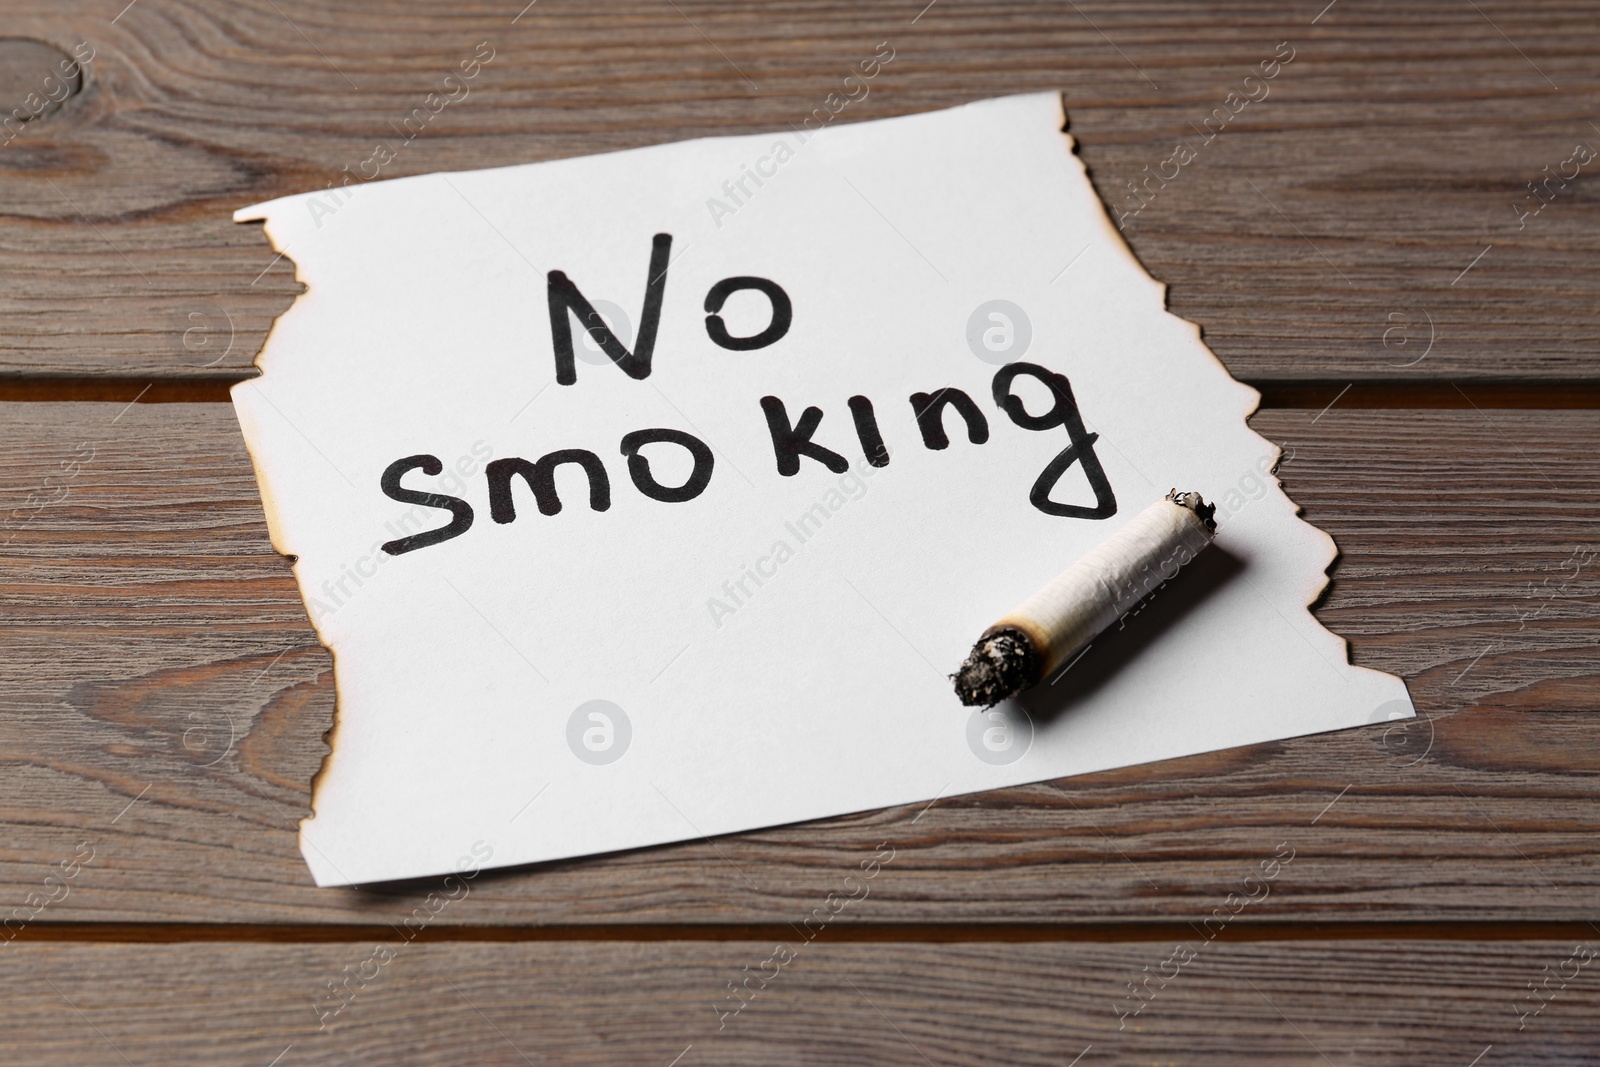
(950, 490, 1216, 707)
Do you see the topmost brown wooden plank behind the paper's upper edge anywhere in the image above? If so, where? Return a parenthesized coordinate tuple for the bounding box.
(0, 0, 1600, 381)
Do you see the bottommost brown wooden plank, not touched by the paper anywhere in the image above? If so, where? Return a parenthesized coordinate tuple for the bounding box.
(0, 928, 1600, 1067)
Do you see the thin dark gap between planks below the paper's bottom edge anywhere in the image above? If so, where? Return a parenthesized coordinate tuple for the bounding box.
(18, 920, 1600, 944)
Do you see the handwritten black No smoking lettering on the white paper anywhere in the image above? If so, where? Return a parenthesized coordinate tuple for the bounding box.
(379, 234, 1117, 555)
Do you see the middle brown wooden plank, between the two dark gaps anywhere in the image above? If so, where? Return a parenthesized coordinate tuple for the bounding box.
(0, 403, 1600, 926)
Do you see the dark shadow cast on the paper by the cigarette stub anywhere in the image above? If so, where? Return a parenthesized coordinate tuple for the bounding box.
(1016, 542, 1245, 728)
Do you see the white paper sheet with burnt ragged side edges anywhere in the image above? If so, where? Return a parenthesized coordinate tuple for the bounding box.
(234, 94, 1413, 885)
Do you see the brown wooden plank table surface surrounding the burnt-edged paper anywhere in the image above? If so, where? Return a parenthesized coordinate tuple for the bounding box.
(0, 0, 1600, 1067)
